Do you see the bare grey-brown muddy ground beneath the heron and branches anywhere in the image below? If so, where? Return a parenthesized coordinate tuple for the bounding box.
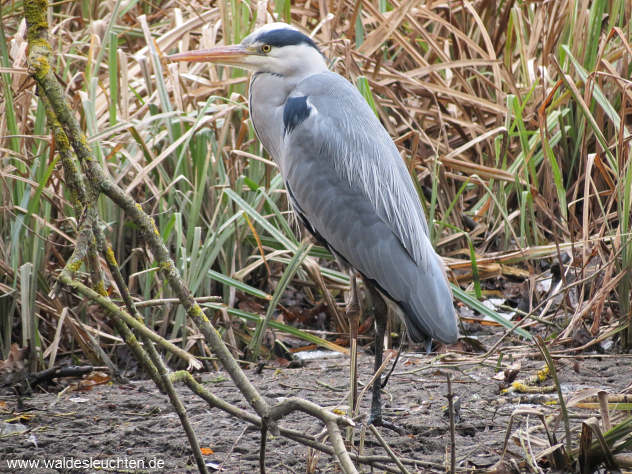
(0, 336, 632, 473)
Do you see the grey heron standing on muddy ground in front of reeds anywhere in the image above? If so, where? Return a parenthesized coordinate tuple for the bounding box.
(169, 23, 458, 424)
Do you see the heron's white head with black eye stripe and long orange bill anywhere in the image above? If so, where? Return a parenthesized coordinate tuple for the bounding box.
(169, 23, 327, 76)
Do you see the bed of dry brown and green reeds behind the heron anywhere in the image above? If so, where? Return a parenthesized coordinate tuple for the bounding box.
(0, 0, 632, 367)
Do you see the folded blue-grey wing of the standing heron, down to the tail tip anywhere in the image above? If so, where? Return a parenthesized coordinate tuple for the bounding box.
(280, 73, 457, 342)
